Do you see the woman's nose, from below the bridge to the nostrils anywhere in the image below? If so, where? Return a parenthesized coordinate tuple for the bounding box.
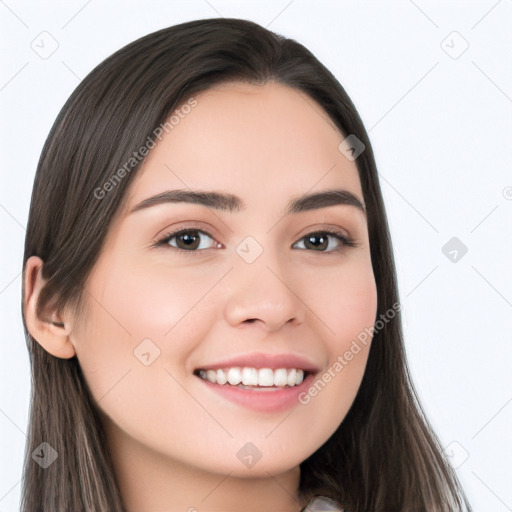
(225, 252, 307, 331)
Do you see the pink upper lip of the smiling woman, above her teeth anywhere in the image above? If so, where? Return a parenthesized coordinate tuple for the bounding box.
(196, 352, 319, 373)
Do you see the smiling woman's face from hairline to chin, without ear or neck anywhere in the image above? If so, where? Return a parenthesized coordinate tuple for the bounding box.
(71, 83, 377, 477)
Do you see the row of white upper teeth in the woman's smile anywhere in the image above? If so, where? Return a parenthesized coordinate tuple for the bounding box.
(199, 367, 304, 387)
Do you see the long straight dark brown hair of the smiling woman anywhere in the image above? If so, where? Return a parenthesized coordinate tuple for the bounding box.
(21, 18, 471, 512)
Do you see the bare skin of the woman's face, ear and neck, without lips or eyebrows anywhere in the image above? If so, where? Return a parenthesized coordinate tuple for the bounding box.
(25, 83, 377, 512)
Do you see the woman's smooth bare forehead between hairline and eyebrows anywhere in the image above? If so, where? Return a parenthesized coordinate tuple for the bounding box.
(122, 82, 363, 212)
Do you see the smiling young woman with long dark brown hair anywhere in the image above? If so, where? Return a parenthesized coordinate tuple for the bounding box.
(21, 19, 471, 512)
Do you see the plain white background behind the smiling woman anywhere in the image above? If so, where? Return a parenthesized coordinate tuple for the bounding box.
(0, 0, 512, 512)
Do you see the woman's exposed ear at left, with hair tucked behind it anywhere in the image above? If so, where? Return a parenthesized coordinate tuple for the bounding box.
(23, 256, 76, 359)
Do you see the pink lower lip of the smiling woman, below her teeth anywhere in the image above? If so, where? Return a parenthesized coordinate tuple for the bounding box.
(197, 373, 314, 412)
